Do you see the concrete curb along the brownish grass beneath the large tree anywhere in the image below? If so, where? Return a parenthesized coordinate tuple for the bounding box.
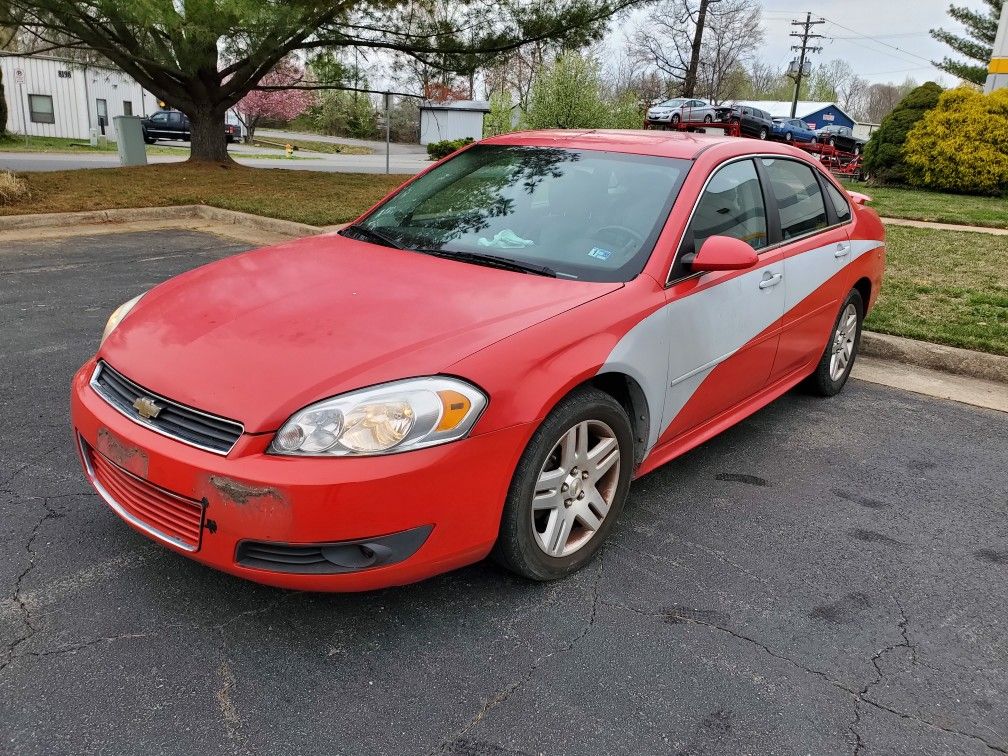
(0, 205, 330, 238)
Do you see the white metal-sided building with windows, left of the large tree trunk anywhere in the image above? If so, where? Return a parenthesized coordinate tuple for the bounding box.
(0, 54, 159, 140)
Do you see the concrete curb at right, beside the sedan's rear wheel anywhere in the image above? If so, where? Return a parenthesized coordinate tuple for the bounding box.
(860, 331, 1008, 384)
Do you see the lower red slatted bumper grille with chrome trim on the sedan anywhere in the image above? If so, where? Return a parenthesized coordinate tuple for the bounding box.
(81, 439, 204, 551)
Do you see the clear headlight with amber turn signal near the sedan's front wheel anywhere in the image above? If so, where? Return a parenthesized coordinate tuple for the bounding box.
(269, 377, 487, 457)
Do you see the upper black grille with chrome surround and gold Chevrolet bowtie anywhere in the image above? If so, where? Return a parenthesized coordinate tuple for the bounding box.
(91, 362, 244, 455)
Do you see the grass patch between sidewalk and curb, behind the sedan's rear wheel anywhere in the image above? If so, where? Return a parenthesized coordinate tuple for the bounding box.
(865, 226, 1008, 355)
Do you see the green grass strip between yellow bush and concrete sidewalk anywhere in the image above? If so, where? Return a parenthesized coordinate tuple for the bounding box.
(844, 181, 1008, 228)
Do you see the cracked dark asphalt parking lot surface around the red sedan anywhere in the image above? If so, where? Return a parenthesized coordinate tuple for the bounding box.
(0, 231, 1008, 755)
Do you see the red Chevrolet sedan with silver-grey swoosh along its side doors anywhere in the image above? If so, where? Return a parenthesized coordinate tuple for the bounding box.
(72, 131, 885, 591)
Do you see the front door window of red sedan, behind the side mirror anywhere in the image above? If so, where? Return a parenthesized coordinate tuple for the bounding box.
(687, 160, 767, 252)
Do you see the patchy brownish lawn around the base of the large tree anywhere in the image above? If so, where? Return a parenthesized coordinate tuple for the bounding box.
(0, 163, 408, 226)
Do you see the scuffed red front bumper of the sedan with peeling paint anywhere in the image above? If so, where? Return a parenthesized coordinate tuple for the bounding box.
(71, 360, 532, 591)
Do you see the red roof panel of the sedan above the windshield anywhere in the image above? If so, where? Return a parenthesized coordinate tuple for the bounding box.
(480, 129, 806, 160)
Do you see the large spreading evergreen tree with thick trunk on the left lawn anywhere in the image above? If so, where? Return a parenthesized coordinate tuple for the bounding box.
(7, 0, 642, 163)
